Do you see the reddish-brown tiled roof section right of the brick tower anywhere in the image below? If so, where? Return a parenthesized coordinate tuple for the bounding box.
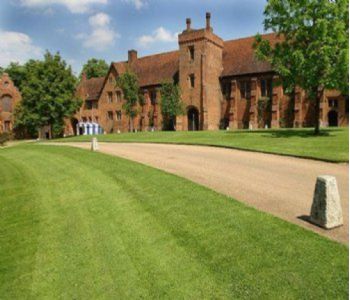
(221, 34, 278, 76)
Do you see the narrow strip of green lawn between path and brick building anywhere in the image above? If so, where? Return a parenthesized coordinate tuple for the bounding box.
(56, 128, 349, 162)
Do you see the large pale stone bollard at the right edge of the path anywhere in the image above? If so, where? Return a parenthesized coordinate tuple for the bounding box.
(310, 175, 343, 229)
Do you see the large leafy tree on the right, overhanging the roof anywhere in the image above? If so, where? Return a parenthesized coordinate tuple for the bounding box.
(255, 0, 349, 134)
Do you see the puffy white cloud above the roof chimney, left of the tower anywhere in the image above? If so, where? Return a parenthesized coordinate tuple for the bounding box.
(76, 13, 119, 51)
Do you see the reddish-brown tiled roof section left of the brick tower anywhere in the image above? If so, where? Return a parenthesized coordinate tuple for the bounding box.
(113, 51, 179, 87)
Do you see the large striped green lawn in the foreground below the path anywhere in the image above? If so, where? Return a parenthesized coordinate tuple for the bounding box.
(0, 144, 348, 299)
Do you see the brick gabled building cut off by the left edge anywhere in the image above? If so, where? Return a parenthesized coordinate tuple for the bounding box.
(0, 73, 21, 133)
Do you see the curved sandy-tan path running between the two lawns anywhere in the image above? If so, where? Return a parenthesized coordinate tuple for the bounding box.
(54, 143, 349, 243)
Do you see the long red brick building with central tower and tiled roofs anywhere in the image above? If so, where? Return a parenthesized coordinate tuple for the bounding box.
(66, 13, 349, 134)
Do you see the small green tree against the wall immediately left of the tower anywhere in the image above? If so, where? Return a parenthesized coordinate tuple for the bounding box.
(160, 82, 184, 130)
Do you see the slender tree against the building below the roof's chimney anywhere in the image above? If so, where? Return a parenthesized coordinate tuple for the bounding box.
(116, 71, 143, 131)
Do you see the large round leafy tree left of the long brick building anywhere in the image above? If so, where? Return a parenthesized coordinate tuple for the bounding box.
(15, 52, 81, 136)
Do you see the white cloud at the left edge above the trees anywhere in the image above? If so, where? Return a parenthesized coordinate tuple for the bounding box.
(0, 30, 44, 67)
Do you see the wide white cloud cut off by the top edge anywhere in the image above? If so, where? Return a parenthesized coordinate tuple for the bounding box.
(19, 0, 106, 13)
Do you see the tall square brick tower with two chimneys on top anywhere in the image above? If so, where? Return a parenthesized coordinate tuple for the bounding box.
(177, 13, 224, 130)
